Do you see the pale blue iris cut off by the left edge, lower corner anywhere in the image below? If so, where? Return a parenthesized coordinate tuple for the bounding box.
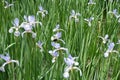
(0, 53, 19, 72)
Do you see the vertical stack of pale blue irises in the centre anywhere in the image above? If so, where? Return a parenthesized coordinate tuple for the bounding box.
(49, 24, 68, 63)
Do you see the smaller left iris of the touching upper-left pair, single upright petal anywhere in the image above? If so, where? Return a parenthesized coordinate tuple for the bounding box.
(9, 18, 20, 37)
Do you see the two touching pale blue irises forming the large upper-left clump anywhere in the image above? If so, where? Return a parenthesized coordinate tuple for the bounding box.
(9, 15, 42, 38)
